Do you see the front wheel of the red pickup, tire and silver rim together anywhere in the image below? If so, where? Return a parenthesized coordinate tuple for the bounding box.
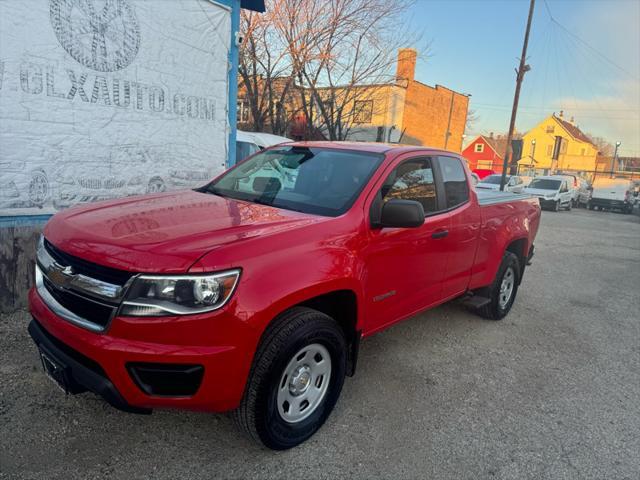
(234, 307, 347, 450)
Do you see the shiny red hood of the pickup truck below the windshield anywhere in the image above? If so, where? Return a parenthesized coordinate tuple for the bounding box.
(44, 190, 330, 273)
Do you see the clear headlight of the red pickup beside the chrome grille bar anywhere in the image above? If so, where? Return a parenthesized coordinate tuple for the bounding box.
(120, 269, 240, 317)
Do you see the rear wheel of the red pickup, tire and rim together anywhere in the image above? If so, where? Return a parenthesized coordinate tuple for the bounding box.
(479, 252, 520, 320)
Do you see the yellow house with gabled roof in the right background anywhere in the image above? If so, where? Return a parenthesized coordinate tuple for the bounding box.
(518, 112, 598, 175)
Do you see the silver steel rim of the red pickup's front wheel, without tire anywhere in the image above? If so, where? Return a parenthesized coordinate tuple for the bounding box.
(277, 343, 331, 423)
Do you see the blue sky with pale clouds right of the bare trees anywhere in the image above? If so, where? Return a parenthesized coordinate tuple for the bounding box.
(406, 0, 640, 156)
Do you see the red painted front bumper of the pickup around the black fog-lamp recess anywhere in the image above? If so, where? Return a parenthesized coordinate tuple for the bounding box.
(29, 289, 259, 412)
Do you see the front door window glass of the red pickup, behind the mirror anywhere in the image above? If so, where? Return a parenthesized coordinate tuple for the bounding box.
(381, 158, 438, 215)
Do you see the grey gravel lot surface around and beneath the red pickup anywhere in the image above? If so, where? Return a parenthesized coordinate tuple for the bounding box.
(0, 210, 640, 479)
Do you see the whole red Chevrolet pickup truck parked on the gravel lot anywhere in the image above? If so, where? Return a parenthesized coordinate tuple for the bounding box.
(29, 142, 540, 449)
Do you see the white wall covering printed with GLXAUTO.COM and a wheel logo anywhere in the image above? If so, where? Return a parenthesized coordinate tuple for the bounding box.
(0, 0, 231, 216)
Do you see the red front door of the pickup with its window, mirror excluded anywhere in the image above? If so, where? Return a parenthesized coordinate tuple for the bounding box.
(364, 157, 450, 333)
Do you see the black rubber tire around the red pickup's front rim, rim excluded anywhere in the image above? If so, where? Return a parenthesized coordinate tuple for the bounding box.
(233, 307, 347, 450)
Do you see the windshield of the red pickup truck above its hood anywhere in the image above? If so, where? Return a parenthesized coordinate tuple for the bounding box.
(200, 146, 384, 217)
